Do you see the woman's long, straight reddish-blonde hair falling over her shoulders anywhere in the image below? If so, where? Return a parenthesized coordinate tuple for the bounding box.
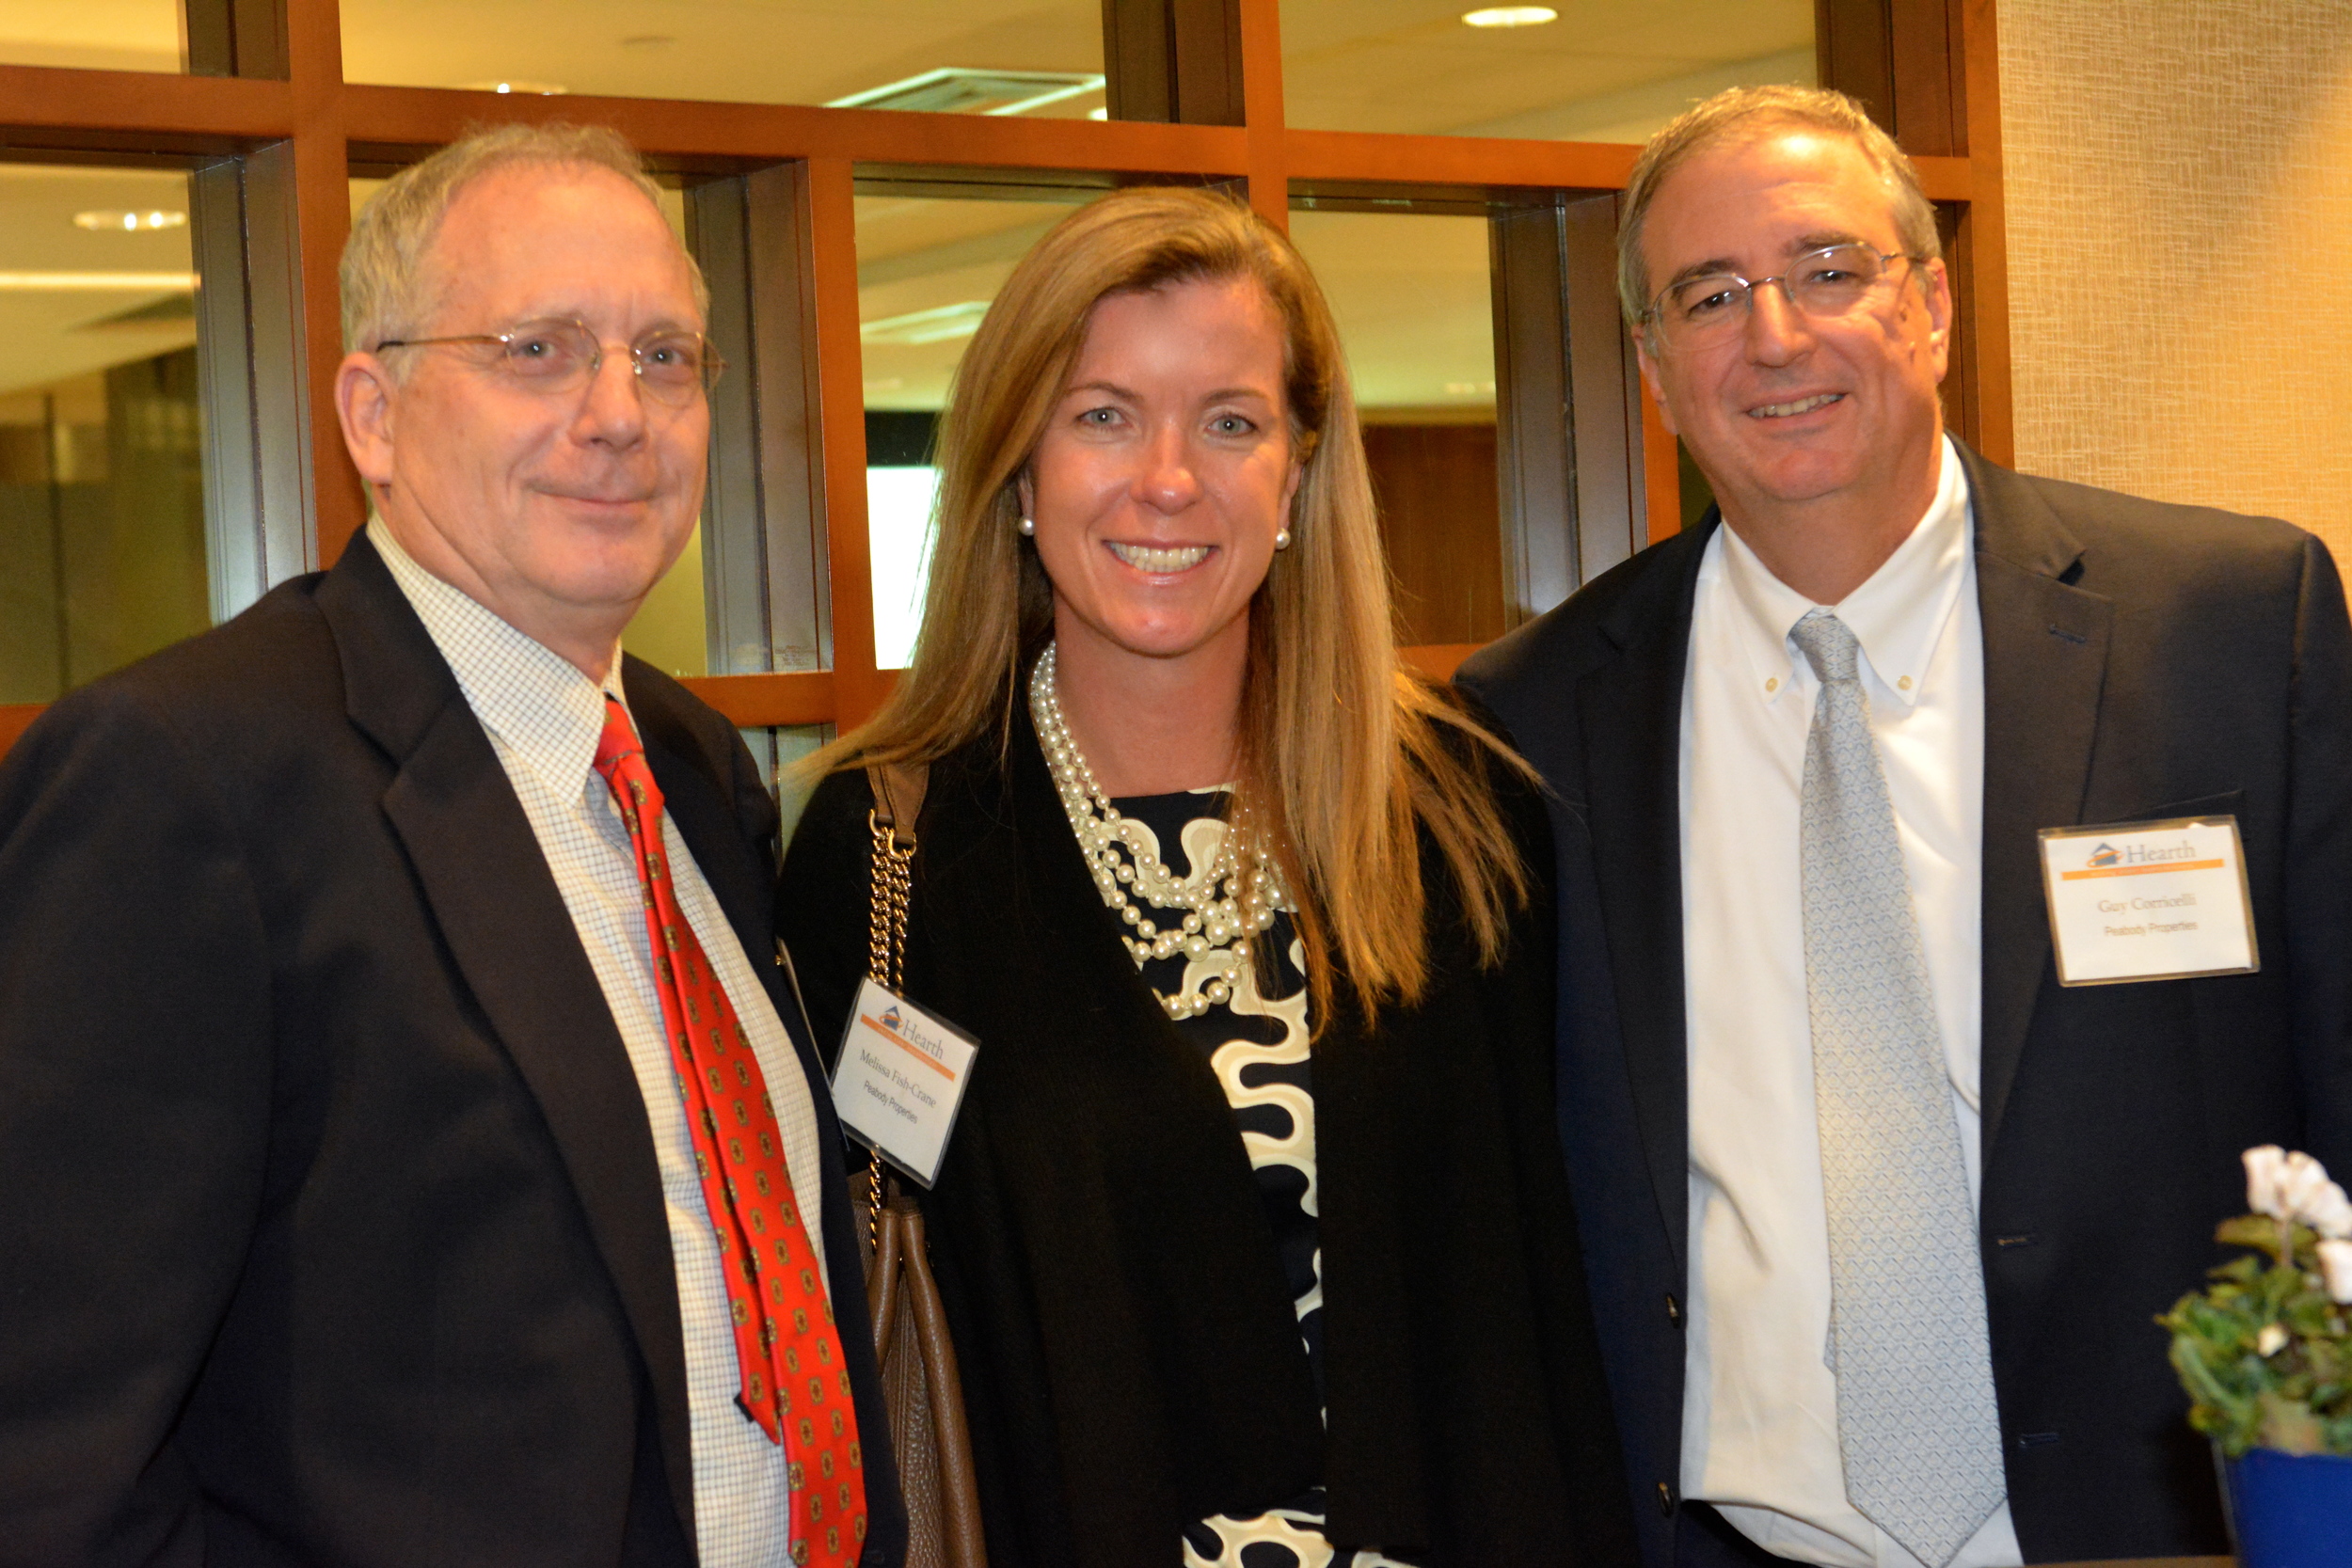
(803, 185, 1527, 1021)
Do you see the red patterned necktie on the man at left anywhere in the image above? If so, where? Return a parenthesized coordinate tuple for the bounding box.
(596, 696, 866, 1568)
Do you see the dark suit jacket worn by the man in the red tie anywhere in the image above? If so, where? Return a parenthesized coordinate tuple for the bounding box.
(0, 538, 903, 1568)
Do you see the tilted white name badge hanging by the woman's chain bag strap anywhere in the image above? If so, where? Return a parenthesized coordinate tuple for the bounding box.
(833, 975, 981, 1187)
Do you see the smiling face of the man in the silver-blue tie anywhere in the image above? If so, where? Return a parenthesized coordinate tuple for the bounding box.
(1642, 127, 1952, 533)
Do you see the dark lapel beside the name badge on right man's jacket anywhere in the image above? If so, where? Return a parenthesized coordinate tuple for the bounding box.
(1960, 447, 2115, 1152)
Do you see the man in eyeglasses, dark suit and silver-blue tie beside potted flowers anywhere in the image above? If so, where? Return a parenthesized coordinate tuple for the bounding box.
(1463, 87, 2352, 1568)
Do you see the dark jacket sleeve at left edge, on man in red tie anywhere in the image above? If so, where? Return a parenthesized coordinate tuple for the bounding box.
(0, 682, 273, 1563)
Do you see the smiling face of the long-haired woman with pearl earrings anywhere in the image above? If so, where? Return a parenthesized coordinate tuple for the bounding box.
(1021, 279, 1298, 673)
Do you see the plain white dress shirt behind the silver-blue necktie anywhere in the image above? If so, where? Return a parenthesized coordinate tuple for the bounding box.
(1682, 442, 2023, 1568)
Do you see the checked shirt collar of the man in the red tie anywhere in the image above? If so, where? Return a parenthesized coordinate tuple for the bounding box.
(367, 517, 635, 800)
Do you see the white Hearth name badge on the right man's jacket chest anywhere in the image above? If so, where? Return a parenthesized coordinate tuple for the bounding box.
(2042, 816, 2263, 985)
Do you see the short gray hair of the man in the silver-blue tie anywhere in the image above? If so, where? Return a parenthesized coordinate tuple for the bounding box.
(1618, 87, 1943, 331)
